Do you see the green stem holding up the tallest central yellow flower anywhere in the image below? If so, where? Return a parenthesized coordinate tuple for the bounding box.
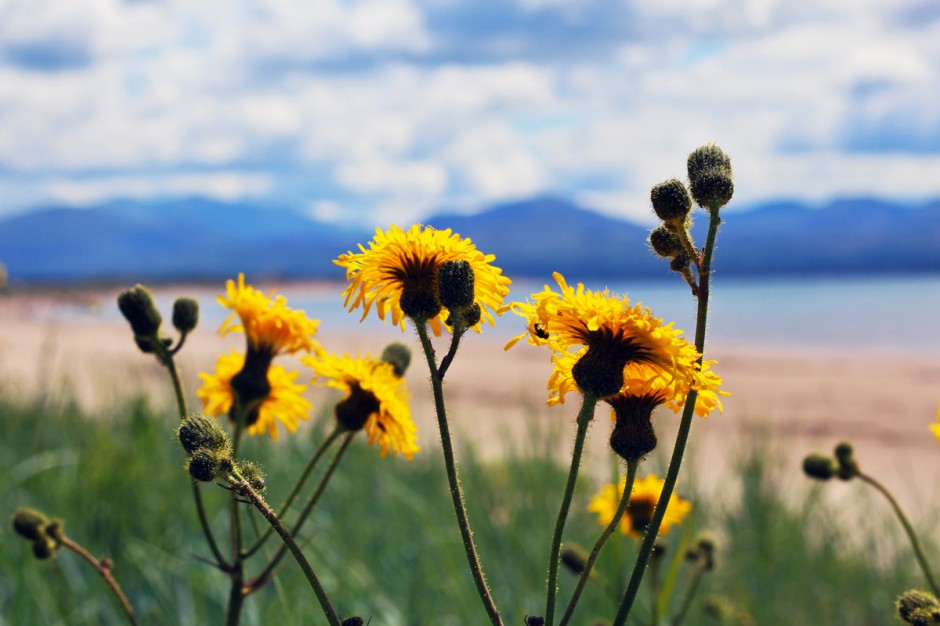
(414, 320, 503, 626)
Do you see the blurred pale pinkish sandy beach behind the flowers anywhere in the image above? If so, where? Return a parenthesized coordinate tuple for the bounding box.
(0, 289, 940, 517)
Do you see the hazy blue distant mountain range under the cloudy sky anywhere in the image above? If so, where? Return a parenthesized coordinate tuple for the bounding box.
(0, 197, 940, 284)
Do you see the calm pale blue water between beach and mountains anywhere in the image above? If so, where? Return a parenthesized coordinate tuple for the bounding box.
(79, 274, 940, 357)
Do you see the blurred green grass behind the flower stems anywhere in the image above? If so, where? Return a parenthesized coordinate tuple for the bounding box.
(0, 392, 922, 626)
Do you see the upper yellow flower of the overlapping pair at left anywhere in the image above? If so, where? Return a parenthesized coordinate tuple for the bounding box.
(218, 274, 320, 356)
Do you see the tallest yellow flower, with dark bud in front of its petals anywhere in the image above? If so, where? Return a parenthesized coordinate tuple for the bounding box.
(334, 224, 510, 335)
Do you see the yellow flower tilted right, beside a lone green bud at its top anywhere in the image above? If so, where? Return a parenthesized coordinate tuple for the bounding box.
(302, 352, 419, 460)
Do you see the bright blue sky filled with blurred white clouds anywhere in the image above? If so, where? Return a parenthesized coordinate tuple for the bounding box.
(0, 0, 940, 225)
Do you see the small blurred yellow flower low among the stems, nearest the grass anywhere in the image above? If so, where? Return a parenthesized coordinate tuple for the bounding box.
(587, 474, 692, 539)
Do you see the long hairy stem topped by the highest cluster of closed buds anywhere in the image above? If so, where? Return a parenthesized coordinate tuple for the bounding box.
(613, 207, 721, 626)
